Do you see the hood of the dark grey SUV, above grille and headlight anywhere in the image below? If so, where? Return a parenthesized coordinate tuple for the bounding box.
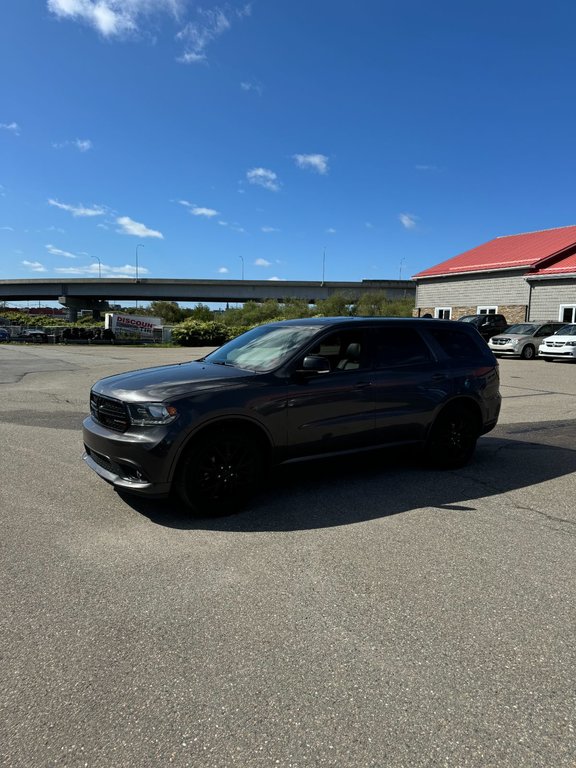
(92, 361, 258, 403)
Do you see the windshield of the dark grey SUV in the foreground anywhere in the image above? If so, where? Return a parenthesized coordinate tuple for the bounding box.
(203, 325, 319, 373)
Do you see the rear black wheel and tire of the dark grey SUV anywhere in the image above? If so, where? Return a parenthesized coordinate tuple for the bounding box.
(425, 404, 479, 469)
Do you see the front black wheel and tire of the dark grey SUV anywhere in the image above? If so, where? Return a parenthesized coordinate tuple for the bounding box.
(174, 428, 265, 517)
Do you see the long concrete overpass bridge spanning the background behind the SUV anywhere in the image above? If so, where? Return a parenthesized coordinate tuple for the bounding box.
(0, 278, 416, 317)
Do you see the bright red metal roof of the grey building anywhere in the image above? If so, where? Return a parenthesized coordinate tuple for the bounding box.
(414, 226, 576, 277)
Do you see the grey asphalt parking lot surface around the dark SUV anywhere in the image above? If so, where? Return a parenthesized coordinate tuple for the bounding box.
(0, 344, 576, 768)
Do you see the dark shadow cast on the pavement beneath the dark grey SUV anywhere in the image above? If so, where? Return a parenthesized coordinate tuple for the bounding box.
(122, 422, 576, 532)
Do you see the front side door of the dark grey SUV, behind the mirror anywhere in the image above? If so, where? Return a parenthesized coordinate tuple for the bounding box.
(286, 328, 375, 455)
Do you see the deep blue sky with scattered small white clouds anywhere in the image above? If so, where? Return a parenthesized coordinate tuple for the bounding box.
(0, 0, 576, 288)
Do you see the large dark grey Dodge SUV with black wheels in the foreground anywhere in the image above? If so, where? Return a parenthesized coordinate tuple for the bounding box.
(83, 318, 500, 514)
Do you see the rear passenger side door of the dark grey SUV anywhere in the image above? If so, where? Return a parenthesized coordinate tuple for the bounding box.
(371, 325, 452, 444)
